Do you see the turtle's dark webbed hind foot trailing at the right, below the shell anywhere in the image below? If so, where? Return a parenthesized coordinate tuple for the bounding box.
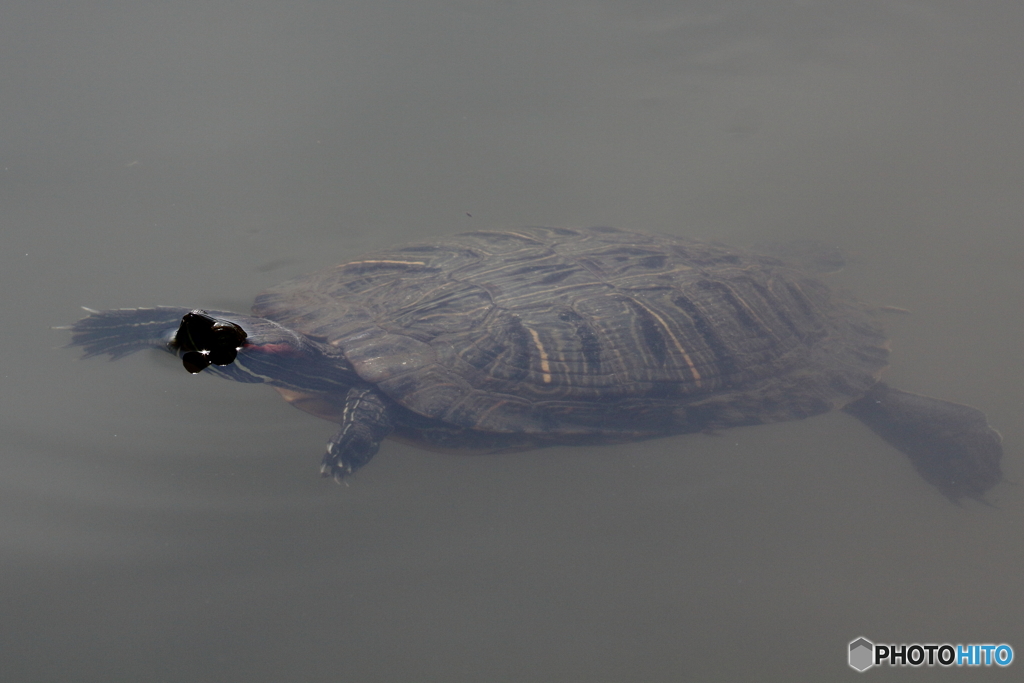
(843, 382, 1002, 503)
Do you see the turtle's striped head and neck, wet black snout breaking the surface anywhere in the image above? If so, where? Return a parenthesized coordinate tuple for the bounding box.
(167, 310, 347, 388)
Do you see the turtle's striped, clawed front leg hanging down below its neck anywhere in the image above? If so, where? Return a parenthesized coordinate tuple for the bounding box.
(321, 388, 394, 481)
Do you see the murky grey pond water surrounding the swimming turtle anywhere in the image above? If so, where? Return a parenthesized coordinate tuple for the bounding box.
(0, 1, 1024, 683)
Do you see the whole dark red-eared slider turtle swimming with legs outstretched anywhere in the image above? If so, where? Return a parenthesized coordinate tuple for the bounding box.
(72, 227, 1002, 501)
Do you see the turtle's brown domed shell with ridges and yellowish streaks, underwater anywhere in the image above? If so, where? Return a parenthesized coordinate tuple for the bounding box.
(253, 227, 888, 440)
